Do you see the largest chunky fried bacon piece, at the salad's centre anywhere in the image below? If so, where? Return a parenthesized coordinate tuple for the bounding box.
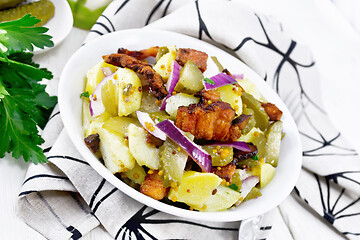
(175, 101, 241, 141)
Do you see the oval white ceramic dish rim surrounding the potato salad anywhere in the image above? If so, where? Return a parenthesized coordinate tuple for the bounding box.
(59, 30, 302, 222)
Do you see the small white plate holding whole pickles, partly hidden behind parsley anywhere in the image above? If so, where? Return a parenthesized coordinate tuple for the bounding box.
(33, 0, 73, 54)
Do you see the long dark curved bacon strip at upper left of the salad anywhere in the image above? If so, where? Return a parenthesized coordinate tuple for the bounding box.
(103, 53, 167, 100)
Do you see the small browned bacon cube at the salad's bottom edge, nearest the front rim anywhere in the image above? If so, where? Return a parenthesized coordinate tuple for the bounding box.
(140, 171, 169, 200)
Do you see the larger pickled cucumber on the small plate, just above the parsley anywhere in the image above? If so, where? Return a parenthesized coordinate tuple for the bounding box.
(0, 0, 55, 26)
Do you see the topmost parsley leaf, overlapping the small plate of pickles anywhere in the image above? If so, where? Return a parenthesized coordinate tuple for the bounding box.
(0, 14, 54, 53)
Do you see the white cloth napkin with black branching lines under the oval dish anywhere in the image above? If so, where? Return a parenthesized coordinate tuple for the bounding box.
(18, 0, 360, 239)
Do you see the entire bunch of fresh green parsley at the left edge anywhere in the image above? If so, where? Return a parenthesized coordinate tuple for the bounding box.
(0, 14, 57, 164)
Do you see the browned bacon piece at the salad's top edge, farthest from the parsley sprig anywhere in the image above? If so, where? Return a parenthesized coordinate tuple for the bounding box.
(175, 48, 208, 72)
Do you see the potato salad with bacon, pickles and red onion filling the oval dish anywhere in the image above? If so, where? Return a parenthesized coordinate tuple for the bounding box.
(81, 46, 284, 212)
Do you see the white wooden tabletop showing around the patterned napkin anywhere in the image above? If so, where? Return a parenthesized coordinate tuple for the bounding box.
(0, 0, 360, 240)
